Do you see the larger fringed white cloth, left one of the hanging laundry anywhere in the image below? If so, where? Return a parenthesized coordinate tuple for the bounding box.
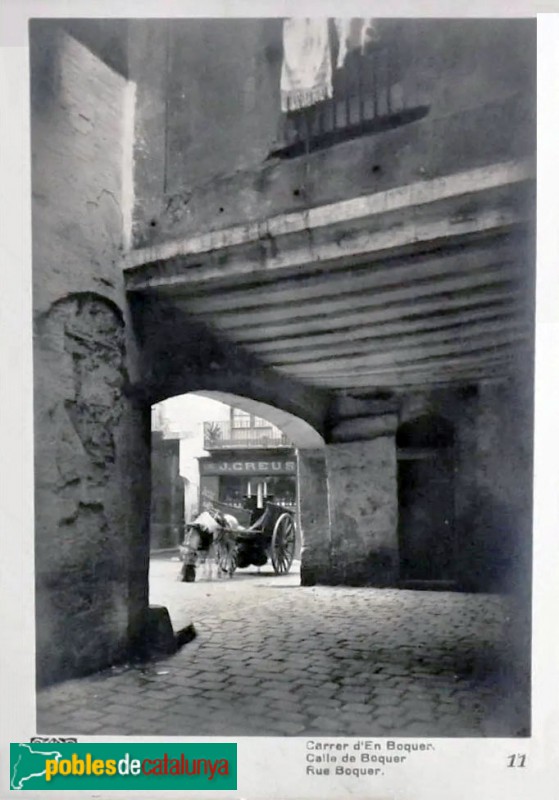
(281, 17, 332, 111)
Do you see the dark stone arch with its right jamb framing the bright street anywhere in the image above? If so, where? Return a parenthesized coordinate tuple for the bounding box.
(130, 296, 332, 584)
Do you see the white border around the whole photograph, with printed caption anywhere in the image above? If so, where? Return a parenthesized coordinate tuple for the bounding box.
(0, 0, 559, 800)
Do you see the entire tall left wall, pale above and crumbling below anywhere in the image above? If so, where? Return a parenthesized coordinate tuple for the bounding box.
(31, 26, 149, 684)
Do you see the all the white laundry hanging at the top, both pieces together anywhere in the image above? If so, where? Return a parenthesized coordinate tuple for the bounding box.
(281, 17, 377, 111)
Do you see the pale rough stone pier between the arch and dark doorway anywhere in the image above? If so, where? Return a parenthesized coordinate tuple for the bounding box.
(326, 414, 399, 586)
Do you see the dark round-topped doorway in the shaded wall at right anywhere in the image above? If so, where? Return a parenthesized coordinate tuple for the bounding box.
(396, 416, 456, 584)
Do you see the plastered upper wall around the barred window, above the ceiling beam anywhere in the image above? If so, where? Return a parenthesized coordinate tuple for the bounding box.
(129, 19, 536, 246)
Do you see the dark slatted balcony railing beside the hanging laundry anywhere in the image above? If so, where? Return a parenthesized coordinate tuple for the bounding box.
(269, 25, 429, 158)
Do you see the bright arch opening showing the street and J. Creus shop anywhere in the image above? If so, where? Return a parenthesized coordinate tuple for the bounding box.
(149, 391, 328, 629)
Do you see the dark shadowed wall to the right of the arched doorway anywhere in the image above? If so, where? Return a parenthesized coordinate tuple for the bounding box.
(400, 378, 533, 594)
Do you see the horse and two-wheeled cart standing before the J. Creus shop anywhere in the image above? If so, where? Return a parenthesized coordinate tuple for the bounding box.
(181, 502, 297, 581)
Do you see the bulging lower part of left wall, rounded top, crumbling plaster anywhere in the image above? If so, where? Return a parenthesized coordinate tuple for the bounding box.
(35, 293, 153, 684)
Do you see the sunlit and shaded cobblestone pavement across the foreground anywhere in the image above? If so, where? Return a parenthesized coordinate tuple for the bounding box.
(37, 559, 527, 737)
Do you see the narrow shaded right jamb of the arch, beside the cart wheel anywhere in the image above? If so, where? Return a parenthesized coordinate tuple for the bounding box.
(297, 450, 331, 586)
